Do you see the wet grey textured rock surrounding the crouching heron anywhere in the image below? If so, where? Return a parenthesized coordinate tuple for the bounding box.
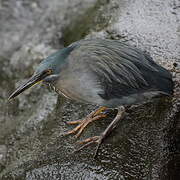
(0, 0, 180, 180)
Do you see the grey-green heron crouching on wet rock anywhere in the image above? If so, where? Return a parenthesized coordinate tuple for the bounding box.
(8, 38, 174, 157)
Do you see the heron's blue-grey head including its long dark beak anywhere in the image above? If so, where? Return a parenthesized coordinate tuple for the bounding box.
(8, 45, 72, 100)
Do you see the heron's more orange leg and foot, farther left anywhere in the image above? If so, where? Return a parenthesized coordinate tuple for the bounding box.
(64, 107, 107, 138)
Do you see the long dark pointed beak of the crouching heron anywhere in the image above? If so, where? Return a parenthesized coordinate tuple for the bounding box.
(8, 72, 50, 100)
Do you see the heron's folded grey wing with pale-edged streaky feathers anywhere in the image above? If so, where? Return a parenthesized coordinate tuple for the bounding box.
(68, 39, 171, 99)
